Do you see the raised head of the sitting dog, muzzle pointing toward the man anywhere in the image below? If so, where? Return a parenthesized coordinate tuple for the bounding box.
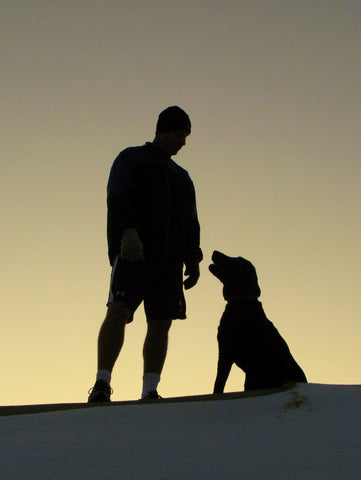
(209, 250, 261, 302)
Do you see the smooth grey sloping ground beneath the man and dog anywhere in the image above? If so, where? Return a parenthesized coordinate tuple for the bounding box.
(0, 384, 361, 480)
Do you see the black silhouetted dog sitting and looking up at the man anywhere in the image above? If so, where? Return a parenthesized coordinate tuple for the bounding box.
(209, 251, 307, 393)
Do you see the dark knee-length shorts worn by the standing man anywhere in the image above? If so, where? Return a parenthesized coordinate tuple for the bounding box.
(108, 257, 186, 323)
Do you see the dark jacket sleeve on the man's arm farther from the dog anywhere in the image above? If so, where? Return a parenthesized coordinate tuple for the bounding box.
(107, 151, 136, 265)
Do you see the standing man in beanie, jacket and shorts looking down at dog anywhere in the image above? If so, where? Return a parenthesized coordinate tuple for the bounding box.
(88, 106, 202, 402)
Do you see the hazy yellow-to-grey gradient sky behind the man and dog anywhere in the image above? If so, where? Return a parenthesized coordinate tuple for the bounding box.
(0, 0, 361, 405)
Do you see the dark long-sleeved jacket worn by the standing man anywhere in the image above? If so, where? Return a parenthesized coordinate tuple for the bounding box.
(107, 143, 202, 265)
